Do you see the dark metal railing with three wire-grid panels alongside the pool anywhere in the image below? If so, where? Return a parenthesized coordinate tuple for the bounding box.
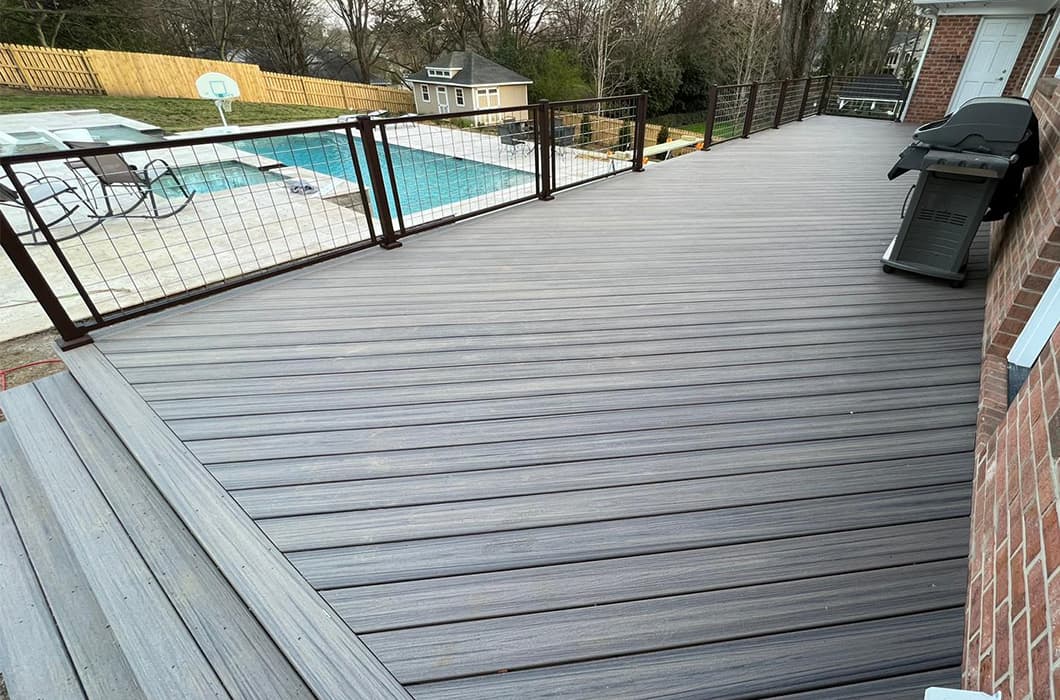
(0, 94, 647, 347)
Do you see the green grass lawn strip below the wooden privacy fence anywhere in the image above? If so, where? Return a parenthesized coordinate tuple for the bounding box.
(0, 93, 343, 132)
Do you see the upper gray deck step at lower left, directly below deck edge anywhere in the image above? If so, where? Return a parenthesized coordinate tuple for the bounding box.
(0, 373, 312, 698)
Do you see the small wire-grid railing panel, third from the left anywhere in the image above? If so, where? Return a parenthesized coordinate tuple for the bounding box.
(547, 95, 638, 190)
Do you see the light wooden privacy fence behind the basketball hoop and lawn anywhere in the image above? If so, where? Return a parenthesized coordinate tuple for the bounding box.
(0, 43, 414, 112)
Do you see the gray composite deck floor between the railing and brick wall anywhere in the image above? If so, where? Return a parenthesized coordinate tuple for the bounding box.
(2, 118, 985, 700)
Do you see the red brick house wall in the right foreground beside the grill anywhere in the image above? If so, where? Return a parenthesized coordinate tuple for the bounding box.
(964, 76, 1060, 700)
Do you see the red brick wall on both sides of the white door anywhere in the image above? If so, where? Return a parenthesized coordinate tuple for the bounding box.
(905, 15, 1047, 124)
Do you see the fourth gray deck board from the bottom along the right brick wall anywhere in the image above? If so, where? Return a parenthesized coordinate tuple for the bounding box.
(324, 518, 968, 632)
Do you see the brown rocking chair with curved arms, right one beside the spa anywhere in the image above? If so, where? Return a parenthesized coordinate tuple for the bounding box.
(66, 141, 195, 218)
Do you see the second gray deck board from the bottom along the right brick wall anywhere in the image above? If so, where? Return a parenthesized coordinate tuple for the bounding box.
(411, 609, 964, 700)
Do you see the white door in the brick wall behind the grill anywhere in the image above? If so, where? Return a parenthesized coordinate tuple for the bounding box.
(950, 16, 1031, 111)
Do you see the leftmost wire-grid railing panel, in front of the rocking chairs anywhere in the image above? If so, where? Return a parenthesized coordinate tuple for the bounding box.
(4, 128, 374, 321)
